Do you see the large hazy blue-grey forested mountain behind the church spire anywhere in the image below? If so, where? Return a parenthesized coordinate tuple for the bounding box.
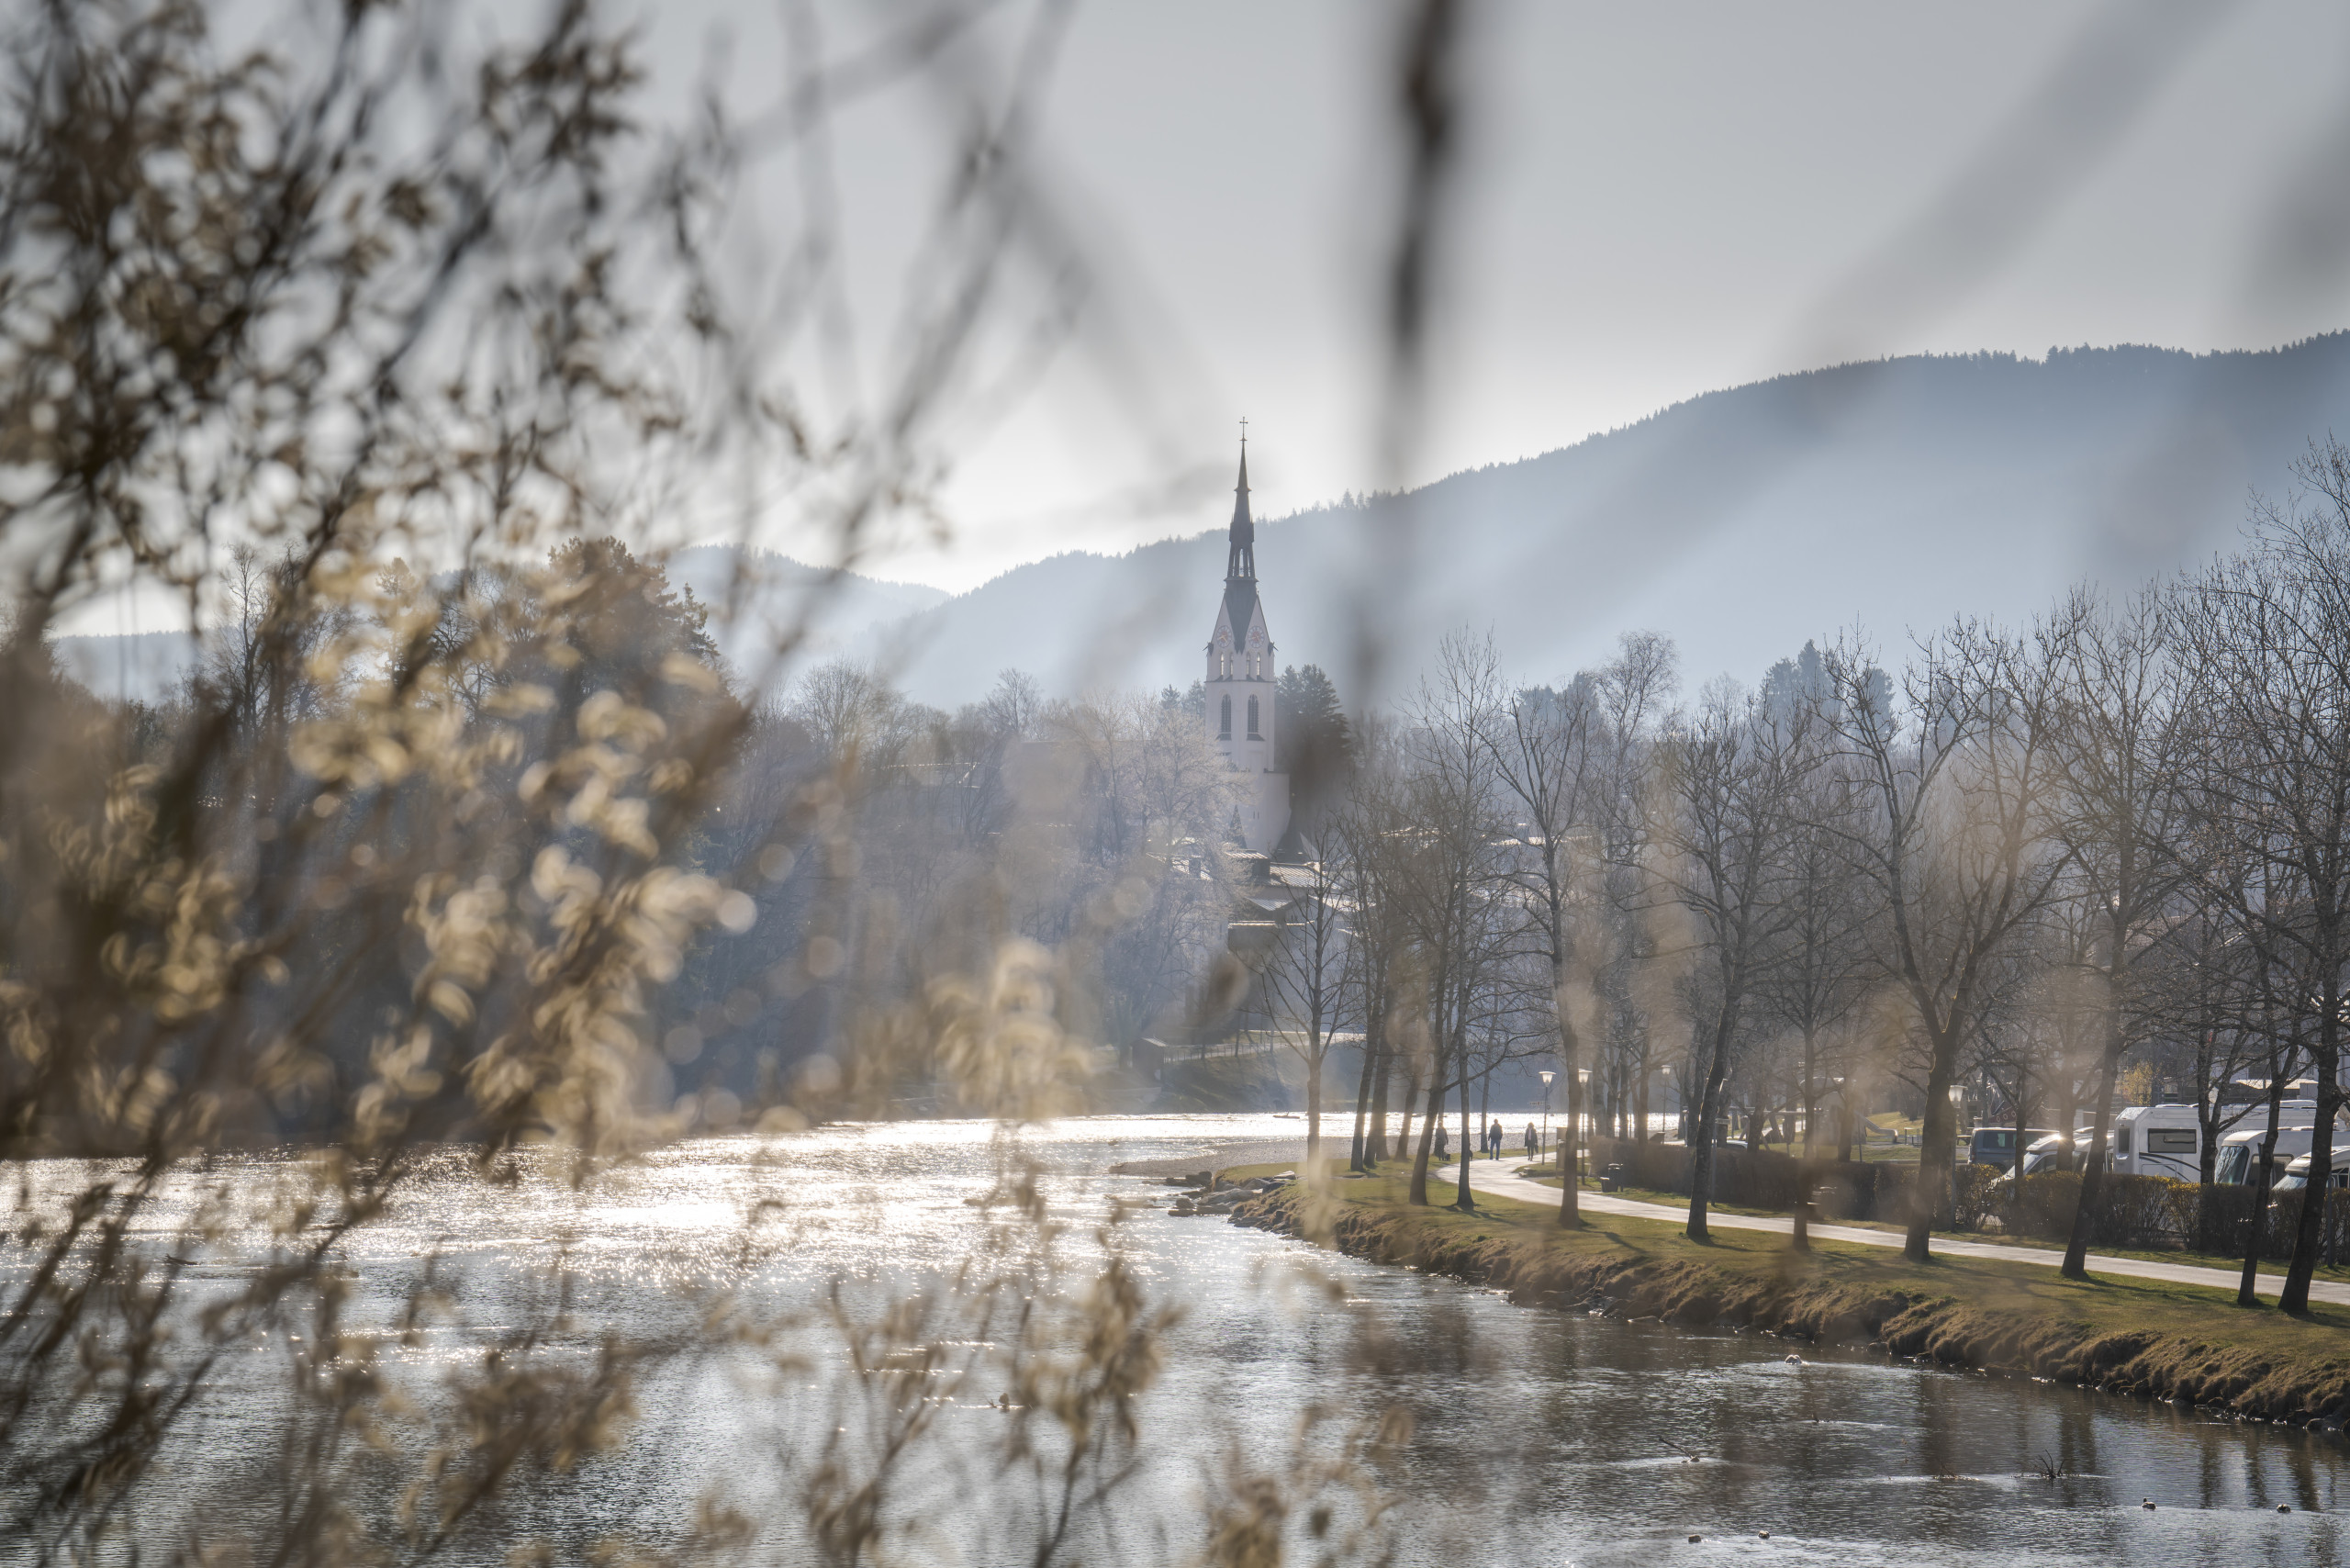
(898, 334, 2350, 703)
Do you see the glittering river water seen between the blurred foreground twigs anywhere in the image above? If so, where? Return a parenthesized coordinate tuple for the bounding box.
(22, 1116, 2350, 1568)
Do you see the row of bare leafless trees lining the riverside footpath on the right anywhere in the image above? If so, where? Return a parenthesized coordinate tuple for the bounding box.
(1269, 442, 2350, 1312)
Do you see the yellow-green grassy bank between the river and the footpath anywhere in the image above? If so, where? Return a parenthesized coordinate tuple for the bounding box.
(1226, 1170, 2350, 1427)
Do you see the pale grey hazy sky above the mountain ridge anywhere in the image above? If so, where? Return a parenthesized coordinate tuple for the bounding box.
(620, 0, 2350, 590)
